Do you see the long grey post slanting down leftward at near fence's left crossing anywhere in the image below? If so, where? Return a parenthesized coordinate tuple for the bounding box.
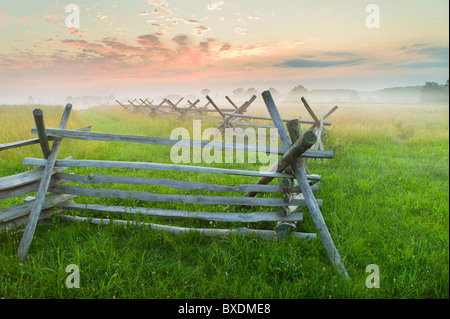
(17, 104, 72, 259)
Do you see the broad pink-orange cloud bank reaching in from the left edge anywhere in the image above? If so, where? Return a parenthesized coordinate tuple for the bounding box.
(0, 28, 314, 92)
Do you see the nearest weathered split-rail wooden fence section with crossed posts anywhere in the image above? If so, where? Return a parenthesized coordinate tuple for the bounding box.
(0, 91, 347, 276)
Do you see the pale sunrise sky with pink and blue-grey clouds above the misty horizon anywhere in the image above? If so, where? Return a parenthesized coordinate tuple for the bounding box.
(0, 0, 449, 102)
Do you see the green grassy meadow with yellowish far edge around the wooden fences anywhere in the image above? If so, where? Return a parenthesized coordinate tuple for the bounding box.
(0, 105, 449, 299)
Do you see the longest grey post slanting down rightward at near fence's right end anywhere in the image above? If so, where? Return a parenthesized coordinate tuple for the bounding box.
(262, 91, 348, 278)
